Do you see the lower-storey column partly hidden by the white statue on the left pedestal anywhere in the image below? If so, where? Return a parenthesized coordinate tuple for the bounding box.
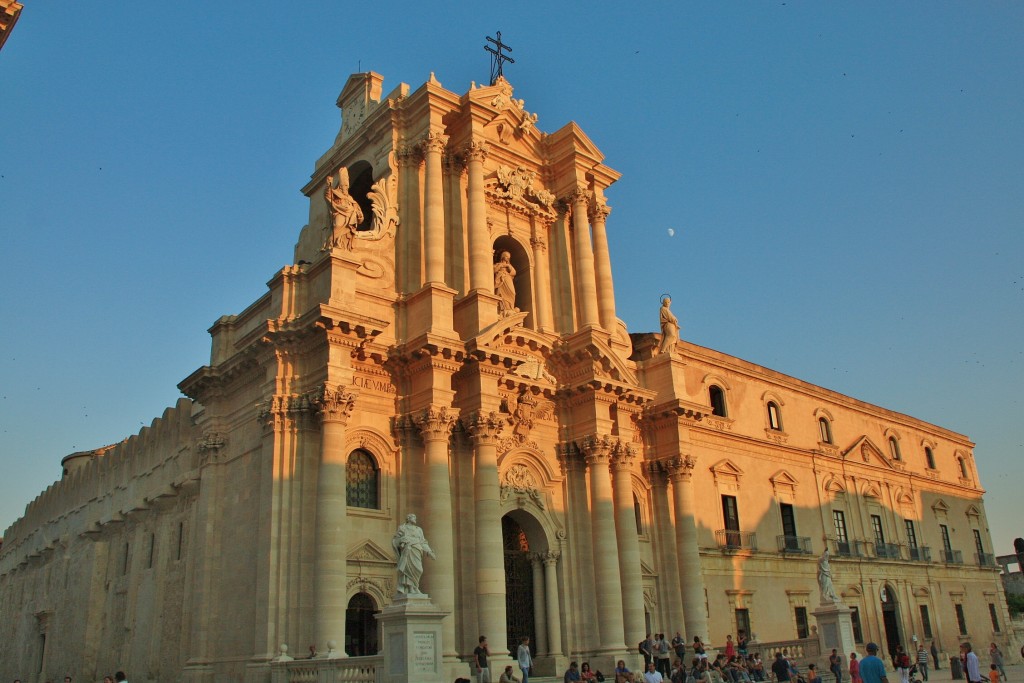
(415, 405, 458, 656)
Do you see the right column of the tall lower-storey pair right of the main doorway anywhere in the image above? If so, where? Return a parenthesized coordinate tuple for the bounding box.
(611, 441, 646, 642)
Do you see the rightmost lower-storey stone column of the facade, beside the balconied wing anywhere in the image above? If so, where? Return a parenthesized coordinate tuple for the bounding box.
(665, 456, 711, 638)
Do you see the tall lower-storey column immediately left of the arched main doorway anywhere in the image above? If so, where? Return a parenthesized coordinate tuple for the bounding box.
(463, 411, 508, 657)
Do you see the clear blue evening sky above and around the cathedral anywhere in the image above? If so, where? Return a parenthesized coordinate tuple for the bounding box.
(0, 0, 1024, 554)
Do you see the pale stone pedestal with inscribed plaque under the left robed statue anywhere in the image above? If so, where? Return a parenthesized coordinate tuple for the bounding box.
(376, 594, 447, 683)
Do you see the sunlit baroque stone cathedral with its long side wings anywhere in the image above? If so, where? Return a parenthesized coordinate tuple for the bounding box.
(0, 72, 1016, 683)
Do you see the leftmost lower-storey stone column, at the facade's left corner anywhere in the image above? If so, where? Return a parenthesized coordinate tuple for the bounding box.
(314, 387, 355, 652)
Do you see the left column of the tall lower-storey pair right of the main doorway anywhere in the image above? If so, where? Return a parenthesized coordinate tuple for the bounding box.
(582, 436, 626, 651)
